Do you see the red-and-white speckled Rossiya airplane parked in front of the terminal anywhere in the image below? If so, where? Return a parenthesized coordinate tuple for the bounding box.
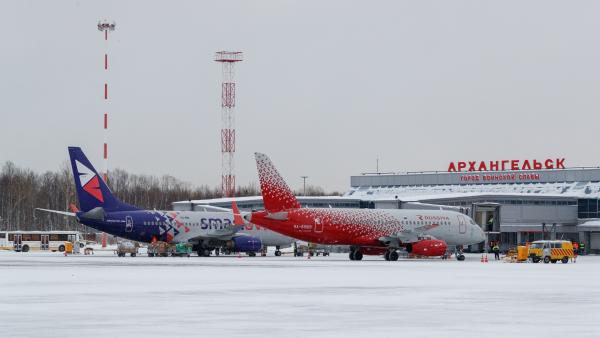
(244, 153, 485, 261)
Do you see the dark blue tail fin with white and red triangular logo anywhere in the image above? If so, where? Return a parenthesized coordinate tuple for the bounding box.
(69, 147, 138, 211)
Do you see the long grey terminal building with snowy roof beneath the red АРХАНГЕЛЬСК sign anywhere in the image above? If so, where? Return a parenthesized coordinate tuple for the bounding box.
(173, 161, 600, 253)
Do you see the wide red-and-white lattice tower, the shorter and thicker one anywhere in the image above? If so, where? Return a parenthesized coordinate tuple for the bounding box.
(215, 51, 243, 197)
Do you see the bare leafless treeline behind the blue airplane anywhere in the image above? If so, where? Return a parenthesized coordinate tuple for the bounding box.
(0, 162, 337, 231)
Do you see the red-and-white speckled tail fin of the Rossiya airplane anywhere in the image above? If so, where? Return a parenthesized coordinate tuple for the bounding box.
(254, 153, 301, 212)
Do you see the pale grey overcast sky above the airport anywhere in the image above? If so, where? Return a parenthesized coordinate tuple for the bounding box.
(0, 0, 600, 190)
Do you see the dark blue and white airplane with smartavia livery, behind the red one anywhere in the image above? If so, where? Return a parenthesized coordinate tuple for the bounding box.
(37, 147, 291, 256)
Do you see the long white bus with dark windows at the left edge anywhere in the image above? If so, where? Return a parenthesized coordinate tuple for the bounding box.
(0, 231, 80, 252)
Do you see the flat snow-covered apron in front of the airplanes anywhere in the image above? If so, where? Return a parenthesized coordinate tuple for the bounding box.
(0, 252, 600, 338)
